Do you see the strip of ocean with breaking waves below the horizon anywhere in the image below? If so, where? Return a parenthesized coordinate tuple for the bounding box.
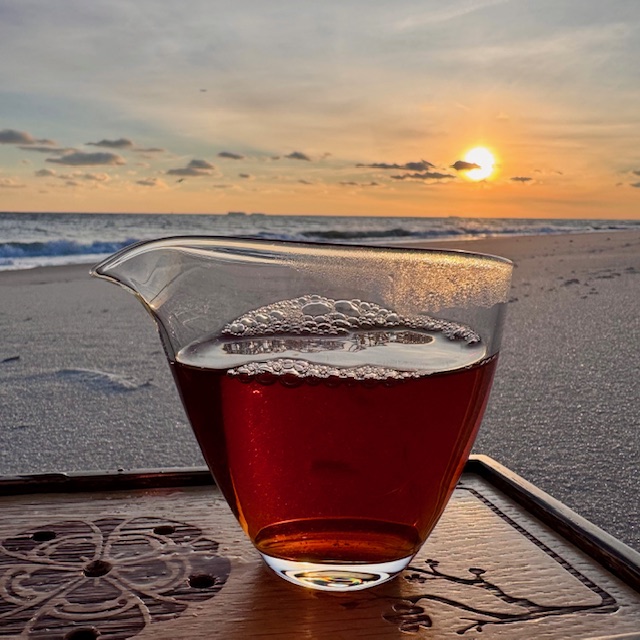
(0, 212, 640, 270)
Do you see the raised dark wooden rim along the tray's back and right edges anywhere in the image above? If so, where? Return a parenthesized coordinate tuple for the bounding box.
(0, 455, 640, 592)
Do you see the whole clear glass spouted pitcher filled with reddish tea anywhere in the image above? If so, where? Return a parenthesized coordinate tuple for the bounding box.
(92, 237, 512, 591)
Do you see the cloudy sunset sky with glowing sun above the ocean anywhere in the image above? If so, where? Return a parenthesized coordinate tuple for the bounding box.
(0, 0, 640, 219)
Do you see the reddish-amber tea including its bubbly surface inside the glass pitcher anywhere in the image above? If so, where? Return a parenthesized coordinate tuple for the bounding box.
(172, 296, 496, 588)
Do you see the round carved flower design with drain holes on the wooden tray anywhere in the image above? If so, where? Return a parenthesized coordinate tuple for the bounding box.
(0, 517, 231, 640)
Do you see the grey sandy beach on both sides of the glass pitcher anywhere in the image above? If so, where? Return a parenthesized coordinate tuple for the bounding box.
(0, 231, 640, 549)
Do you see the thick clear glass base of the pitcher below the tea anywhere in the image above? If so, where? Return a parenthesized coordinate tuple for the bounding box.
(260, 553, 413, 592)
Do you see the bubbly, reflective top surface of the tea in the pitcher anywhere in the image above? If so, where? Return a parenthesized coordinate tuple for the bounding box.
(177, 295, 486, 380)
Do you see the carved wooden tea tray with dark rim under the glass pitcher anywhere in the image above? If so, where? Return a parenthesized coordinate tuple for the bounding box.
(0, 456, 640, 640)
